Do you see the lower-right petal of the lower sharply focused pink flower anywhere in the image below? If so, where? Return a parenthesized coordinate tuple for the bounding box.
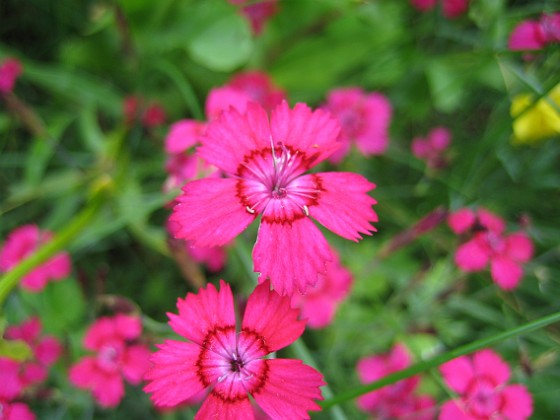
(253, 359, 325, 419)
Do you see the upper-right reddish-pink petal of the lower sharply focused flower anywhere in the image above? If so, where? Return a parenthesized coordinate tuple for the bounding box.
(242, 281, 305, 356)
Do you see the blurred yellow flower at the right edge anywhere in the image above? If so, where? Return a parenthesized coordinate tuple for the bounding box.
(510, 84, 560, 144)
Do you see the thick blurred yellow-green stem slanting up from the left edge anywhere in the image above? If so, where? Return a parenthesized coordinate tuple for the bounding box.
(0, 191, 103, 308)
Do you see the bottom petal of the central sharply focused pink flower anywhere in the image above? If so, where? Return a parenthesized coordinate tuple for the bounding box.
(253, 216, 332, 295)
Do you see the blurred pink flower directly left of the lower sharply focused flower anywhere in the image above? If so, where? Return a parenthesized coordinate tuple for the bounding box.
(70, 314, 150, 407)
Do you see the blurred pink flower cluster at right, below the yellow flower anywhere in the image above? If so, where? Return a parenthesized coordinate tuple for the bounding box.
(448, 208, 533, 290)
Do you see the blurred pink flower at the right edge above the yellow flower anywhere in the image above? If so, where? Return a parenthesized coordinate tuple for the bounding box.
(508, 13, 560, 59)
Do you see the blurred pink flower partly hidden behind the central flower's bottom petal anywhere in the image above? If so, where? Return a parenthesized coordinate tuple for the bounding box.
(292, 250, 352, 328)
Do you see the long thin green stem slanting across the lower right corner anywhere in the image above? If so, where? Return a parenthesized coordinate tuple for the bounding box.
(320, 312, 560, 409)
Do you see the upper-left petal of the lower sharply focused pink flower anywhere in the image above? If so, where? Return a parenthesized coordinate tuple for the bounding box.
(167, 280, 235, 345)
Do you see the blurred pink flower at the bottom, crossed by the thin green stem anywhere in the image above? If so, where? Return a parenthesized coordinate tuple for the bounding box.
(357, 344, 435, 420)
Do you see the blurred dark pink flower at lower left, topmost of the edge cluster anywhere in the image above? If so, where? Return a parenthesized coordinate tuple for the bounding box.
(4, 317, 62, 386)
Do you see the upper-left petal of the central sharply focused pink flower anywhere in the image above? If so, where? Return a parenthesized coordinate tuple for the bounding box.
(198, 102, 272, 174)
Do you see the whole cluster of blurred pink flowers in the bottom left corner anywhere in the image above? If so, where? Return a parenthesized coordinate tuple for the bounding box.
(0, 317, 62, 420)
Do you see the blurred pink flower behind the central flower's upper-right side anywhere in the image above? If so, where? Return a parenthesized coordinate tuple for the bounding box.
(324, 88, 392, 163)
